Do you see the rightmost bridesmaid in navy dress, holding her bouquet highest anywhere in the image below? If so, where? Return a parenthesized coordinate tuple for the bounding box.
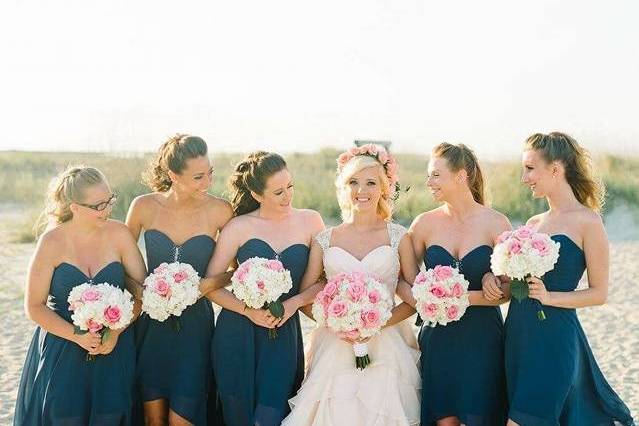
(496, 132, 634, 426)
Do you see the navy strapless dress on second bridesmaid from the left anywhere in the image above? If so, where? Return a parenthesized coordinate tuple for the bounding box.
(135, 229, 222, 426)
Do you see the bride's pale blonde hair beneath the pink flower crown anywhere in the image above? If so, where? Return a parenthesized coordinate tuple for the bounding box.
(335, 155, 393, 221)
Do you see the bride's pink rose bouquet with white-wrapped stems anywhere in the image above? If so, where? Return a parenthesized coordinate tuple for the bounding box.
(313, 272, 393, 370)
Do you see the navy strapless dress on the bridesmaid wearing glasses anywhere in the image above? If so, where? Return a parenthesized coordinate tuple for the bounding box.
(13, 262, 135, 426)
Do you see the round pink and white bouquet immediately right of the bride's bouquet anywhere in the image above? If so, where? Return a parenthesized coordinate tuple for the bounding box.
(412, 265, 470, 327)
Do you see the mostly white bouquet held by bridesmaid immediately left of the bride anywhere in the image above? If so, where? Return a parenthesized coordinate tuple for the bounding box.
(231, 257, 293, 339)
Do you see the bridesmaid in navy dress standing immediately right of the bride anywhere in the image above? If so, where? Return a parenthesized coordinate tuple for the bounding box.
(409, 143, 511, 426)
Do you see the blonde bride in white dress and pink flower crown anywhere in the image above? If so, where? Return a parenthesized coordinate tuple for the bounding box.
(282, 145, 421, 426)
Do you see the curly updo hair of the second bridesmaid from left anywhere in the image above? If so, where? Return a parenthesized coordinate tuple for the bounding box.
(142, 133, 208, 192)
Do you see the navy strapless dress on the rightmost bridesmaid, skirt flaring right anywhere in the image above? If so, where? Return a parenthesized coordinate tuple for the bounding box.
(505, 234, 634, 426)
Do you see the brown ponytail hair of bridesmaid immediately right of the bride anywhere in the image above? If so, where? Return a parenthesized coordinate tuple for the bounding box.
(432, 142, 486, 204)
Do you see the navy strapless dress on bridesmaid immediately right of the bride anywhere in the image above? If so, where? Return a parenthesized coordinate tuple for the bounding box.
(419, 245, 507, 426)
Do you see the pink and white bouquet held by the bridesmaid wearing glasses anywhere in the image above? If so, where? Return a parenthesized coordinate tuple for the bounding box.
(67, 283, 133, 361)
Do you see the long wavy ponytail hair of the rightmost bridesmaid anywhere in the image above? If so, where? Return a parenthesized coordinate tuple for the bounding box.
(526, 132, 606, 212)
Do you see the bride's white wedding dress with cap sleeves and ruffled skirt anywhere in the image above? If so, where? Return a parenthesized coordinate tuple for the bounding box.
(282, 223, 421, 426)
